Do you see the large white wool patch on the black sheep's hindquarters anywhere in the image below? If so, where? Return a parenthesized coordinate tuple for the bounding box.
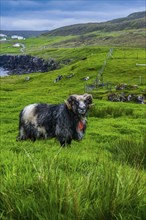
(23, 104, 37, 124)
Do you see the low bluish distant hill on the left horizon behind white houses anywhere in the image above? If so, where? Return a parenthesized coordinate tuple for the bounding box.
(0, 30, 47, 38)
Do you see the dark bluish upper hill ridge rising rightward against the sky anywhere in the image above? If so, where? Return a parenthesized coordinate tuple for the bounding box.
(43, 11, 146, 36)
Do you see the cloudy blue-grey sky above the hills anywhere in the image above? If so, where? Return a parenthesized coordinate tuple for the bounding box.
(0, 0, 146, 30)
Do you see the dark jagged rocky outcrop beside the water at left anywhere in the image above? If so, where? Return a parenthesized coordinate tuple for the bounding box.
(0, 55, 59, 75)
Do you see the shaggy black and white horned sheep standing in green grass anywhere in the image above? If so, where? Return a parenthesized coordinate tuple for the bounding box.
(18, 94, 92, 146)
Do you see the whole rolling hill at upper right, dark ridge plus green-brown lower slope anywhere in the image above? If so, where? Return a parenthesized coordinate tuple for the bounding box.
(42, 11, 146, 48)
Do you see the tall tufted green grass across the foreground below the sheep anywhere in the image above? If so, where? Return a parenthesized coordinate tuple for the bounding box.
(0, 148, 146, 220)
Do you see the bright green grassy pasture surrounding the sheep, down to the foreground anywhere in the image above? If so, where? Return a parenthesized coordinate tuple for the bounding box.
(0, 43, 146, 220)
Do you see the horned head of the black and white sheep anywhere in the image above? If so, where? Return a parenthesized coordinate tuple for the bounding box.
(66, 94, 93, 116)
